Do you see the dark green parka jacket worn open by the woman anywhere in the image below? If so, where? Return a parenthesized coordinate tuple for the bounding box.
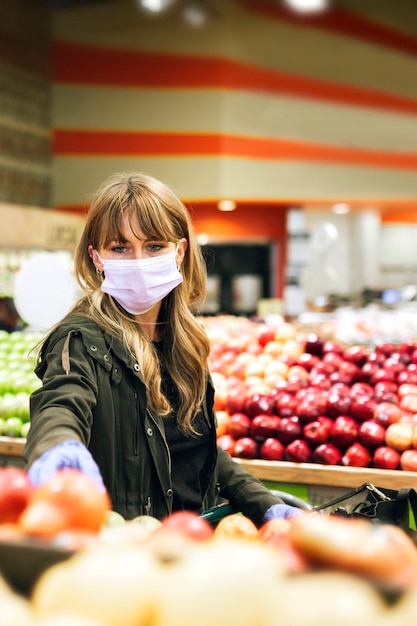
(24, 317, 281, 526)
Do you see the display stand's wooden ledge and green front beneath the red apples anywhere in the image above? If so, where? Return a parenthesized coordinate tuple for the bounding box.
(236, 459, 417, 506)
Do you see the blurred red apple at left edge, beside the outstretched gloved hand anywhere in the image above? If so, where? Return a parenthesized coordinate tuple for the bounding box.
(0, 466, 34, 524)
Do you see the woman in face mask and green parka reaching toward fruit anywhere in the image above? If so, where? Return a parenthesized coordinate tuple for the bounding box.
(25, 173, 300, 525)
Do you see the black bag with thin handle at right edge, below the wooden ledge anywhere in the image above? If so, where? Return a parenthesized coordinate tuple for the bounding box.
(313, 483, 417, 543)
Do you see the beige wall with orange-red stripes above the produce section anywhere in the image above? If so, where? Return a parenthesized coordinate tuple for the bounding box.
(52, 0, 417, 297)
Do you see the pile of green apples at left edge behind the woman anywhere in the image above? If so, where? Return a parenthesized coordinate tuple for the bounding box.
(0, 330, 40, 438)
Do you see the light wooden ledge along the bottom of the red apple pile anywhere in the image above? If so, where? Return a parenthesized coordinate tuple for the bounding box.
(235, 458, 417, 489)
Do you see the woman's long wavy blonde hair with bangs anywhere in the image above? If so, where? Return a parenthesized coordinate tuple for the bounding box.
(63, 172, 210, 434)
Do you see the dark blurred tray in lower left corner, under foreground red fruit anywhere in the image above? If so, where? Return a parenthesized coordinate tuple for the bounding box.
(0, 539, 75, 596)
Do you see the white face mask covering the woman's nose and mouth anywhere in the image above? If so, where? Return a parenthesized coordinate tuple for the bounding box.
(101, 246, 182, 315)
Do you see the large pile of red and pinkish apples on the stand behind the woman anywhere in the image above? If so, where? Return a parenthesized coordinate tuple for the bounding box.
(206, 317, 417, 471)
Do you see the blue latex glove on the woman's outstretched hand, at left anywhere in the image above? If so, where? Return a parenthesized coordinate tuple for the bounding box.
(27, 441, 105, 491)
